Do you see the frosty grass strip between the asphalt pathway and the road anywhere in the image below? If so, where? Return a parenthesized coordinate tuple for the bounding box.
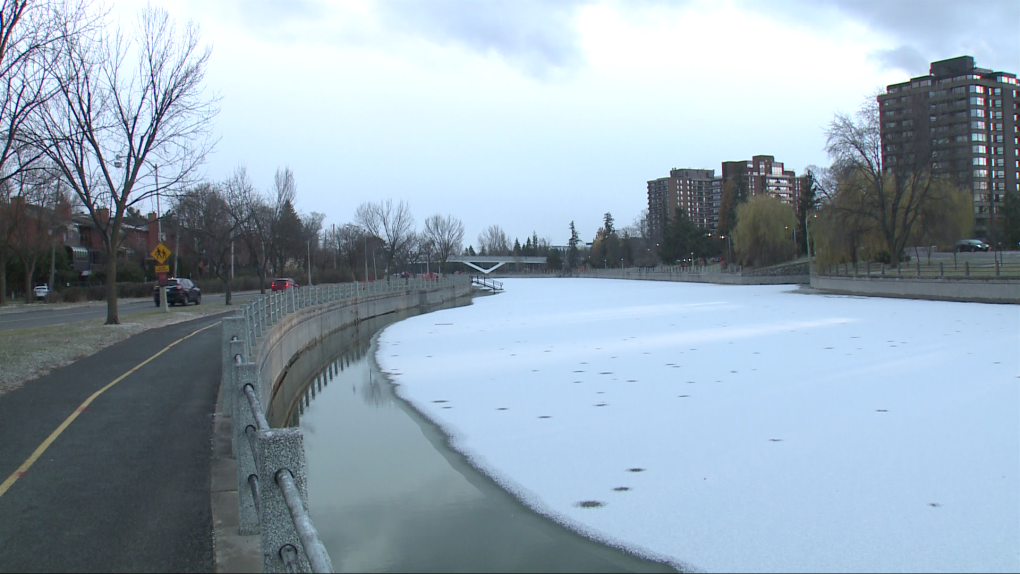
(0, 304, 236, 396)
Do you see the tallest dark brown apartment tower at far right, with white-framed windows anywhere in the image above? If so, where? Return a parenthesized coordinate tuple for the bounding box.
(878, 56, 1020, 238)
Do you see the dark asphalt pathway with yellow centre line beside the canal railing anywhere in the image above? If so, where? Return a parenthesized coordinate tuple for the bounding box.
(0, 311, 229, 572)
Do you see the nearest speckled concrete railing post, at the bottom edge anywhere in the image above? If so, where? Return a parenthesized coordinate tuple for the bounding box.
(258, 428, 311, 572)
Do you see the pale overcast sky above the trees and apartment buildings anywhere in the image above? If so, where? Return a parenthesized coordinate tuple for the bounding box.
(114, 0, 1020, 249)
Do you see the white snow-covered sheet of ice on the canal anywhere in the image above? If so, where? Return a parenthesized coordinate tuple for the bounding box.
(376, 279, 1020, 572)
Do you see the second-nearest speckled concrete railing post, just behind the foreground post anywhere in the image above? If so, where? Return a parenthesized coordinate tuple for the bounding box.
(233, 363, 266, 534)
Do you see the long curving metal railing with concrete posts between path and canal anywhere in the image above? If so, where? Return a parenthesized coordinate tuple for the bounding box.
(222, 277, 466, 573)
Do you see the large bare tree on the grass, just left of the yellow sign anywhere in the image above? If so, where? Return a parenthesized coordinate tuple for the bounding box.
(36, 5, 217, 324)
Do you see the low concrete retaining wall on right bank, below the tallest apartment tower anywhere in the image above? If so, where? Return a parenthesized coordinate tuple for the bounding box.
(811, 275, 1020, 304)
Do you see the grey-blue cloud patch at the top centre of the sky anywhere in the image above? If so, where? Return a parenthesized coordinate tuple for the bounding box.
(375, 0, 588, 79)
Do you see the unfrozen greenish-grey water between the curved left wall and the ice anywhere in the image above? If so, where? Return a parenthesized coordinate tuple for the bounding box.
(290, 303, 673, 572)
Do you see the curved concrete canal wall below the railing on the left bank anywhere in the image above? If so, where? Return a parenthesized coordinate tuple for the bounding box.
(252, 281, 472, 418)
